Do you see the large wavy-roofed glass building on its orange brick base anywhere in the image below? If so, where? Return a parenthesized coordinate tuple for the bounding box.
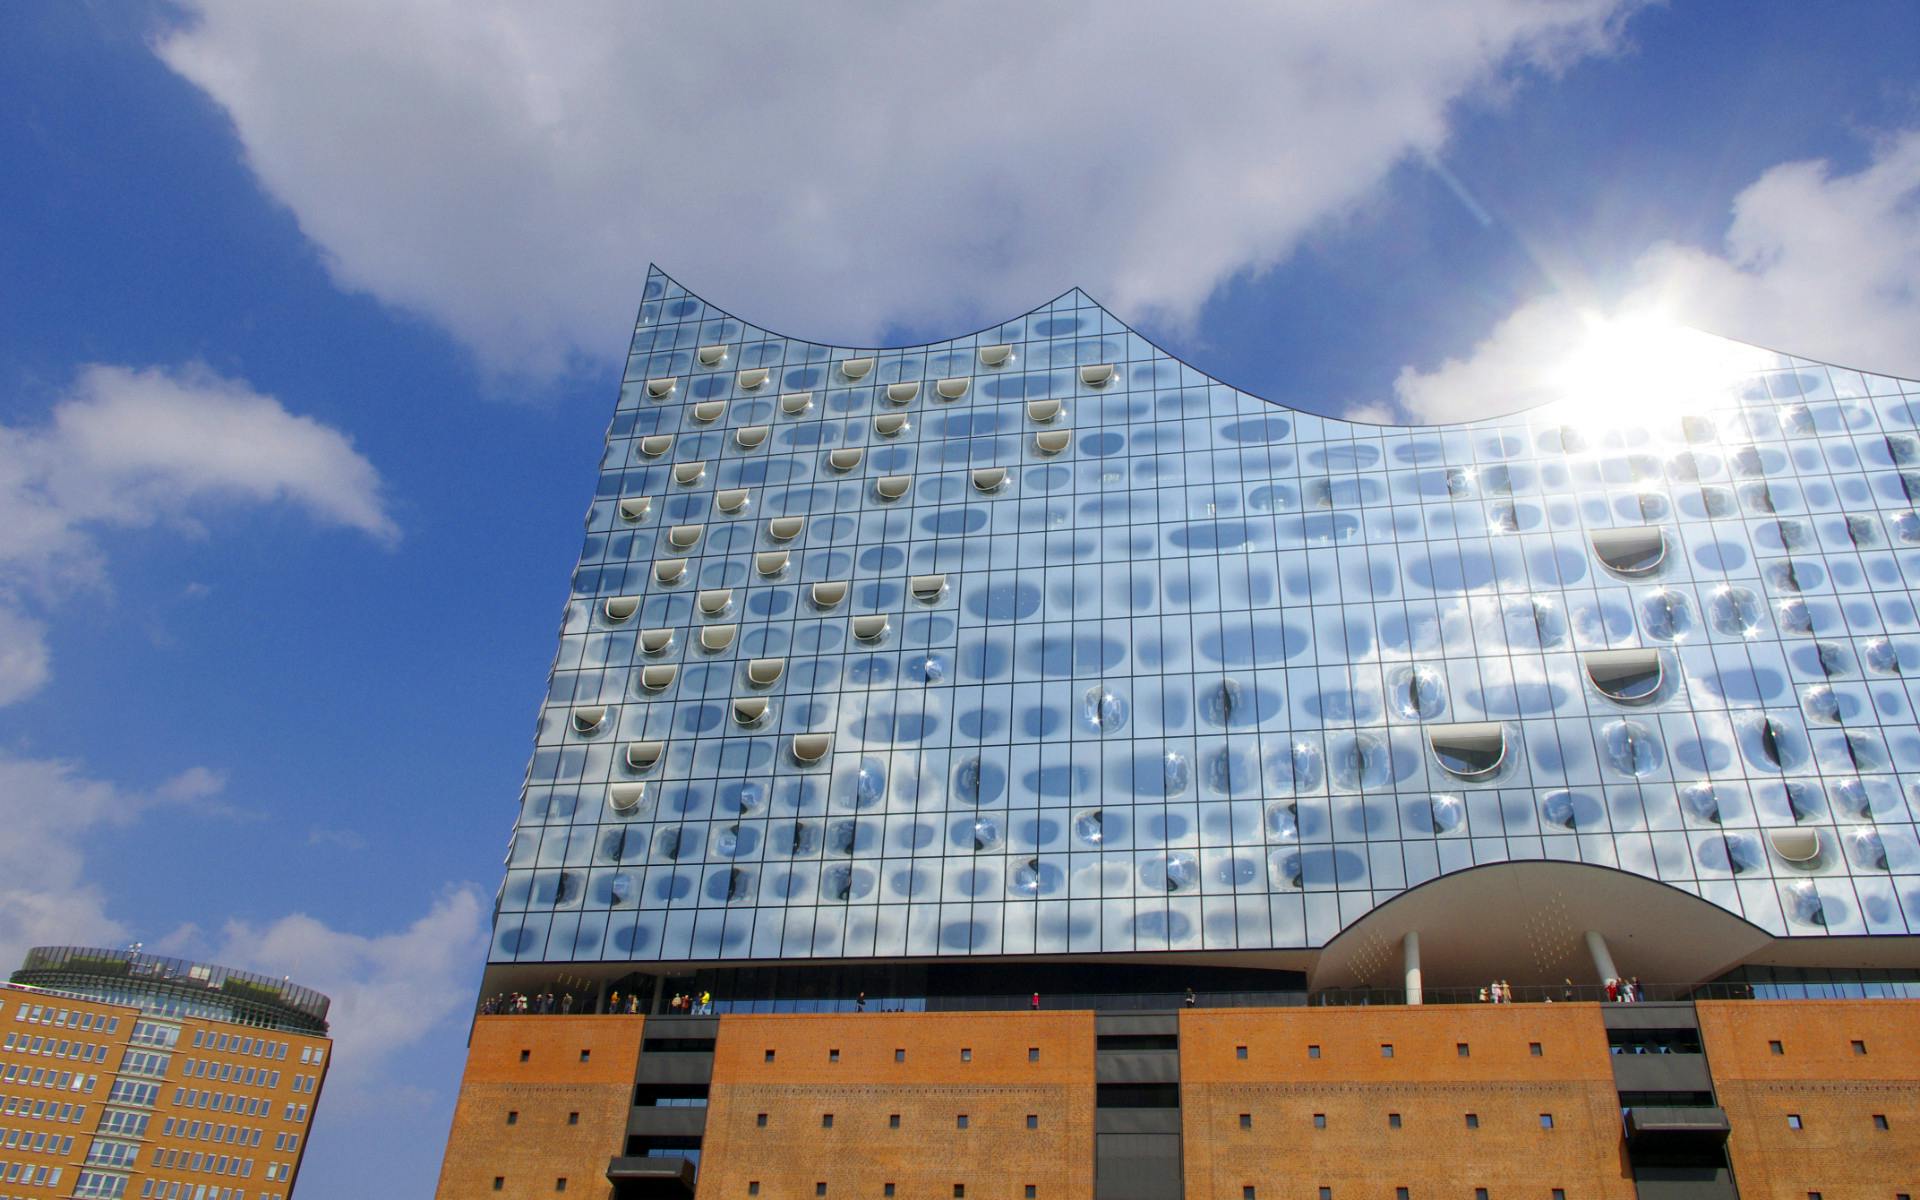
(440, 273, 1920, 1200)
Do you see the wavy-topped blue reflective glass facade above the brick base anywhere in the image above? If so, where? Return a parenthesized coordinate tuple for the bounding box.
(492, 264, 1920, 962)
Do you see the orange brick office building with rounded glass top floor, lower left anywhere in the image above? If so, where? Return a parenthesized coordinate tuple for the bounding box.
(0, 947, 330, 1200)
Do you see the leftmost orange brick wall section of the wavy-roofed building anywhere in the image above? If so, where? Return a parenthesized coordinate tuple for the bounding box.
(434, 1016, 645, 1200)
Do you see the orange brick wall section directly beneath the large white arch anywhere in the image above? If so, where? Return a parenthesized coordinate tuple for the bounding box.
(1181, 1004, 1634, 1200)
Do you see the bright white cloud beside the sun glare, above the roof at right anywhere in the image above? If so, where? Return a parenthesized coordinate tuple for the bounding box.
(1396, 131, 1920, 420)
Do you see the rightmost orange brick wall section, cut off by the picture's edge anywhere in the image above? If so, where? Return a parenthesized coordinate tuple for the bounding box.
(1699, 1000, 1920, 1200)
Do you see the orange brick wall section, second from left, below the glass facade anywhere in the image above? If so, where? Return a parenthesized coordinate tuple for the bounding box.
(699, 1012, 1094, 1200)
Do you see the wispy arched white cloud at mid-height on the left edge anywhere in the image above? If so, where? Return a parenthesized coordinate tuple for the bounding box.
(0, 365, 399, 705)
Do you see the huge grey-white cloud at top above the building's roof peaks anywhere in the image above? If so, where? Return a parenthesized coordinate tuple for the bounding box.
(156, 0, 1640, 372)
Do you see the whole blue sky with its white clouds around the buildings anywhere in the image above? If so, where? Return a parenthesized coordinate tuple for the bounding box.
(0, 0, 1920, 1198)
